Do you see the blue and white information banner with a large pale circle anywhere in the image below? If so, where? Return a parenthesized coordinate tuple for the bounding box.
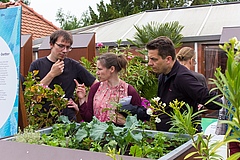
(0, 6, 22, 138)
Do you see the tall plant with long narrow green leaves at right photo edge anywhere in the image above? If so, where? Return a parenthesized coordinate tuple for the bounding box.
(208, 38, 240, 160)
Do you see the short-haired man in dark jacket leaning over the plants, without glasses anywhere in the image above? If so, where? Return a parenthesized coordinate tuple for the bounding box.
(146, 36, 222, 131)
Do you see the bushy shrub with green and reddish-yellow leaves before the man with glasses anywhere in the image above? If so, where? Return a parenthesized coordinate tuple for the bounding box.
(24, 71, 67, 129)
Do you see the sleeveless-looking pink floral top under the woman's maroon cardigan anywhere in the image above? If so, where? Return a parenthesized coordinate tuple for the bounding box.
(93, 80, 128, 122)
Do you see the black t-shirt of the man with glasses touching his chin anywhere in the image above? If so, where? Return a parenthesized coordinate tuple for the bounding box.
(29, 57, 96, 119)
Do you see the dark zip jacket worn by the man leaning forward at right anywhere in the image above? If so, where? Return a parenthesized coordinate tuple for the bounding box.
(156, 61, 221, 131)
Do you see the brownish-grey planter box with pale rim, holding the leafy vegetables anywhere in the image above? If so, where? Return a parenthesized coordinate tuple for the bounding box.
(0, 128, 194, 160)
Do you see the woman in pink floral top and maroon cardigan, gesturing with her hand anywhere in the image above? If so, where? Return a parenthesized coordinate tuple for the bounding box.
(76, 53, 141, 125)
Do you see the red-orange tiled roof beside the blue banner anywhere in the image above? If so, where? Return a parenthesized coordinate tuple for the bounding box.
(3, 1, 60, 40)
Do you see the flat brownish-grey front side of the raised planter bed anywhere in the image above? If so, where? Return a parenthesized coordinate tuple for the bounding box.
(0, 140, 145, 160)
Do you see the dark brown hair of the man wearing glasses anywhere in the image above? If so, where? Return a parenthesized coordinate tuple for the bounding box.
(50, 30, 73, 45)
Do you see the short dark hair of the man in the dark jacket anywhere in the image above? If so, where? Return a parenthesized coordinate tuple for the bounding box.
(146, 36, 176, 60)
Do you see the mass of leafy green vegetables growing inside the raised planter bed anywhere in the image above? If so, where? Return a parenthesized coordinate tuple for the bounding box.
(14, 116, 188, 159)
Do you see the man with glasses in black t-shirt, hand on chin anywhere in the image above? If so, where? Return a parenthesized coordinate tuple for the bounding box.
(29, 30, 96, 120)
